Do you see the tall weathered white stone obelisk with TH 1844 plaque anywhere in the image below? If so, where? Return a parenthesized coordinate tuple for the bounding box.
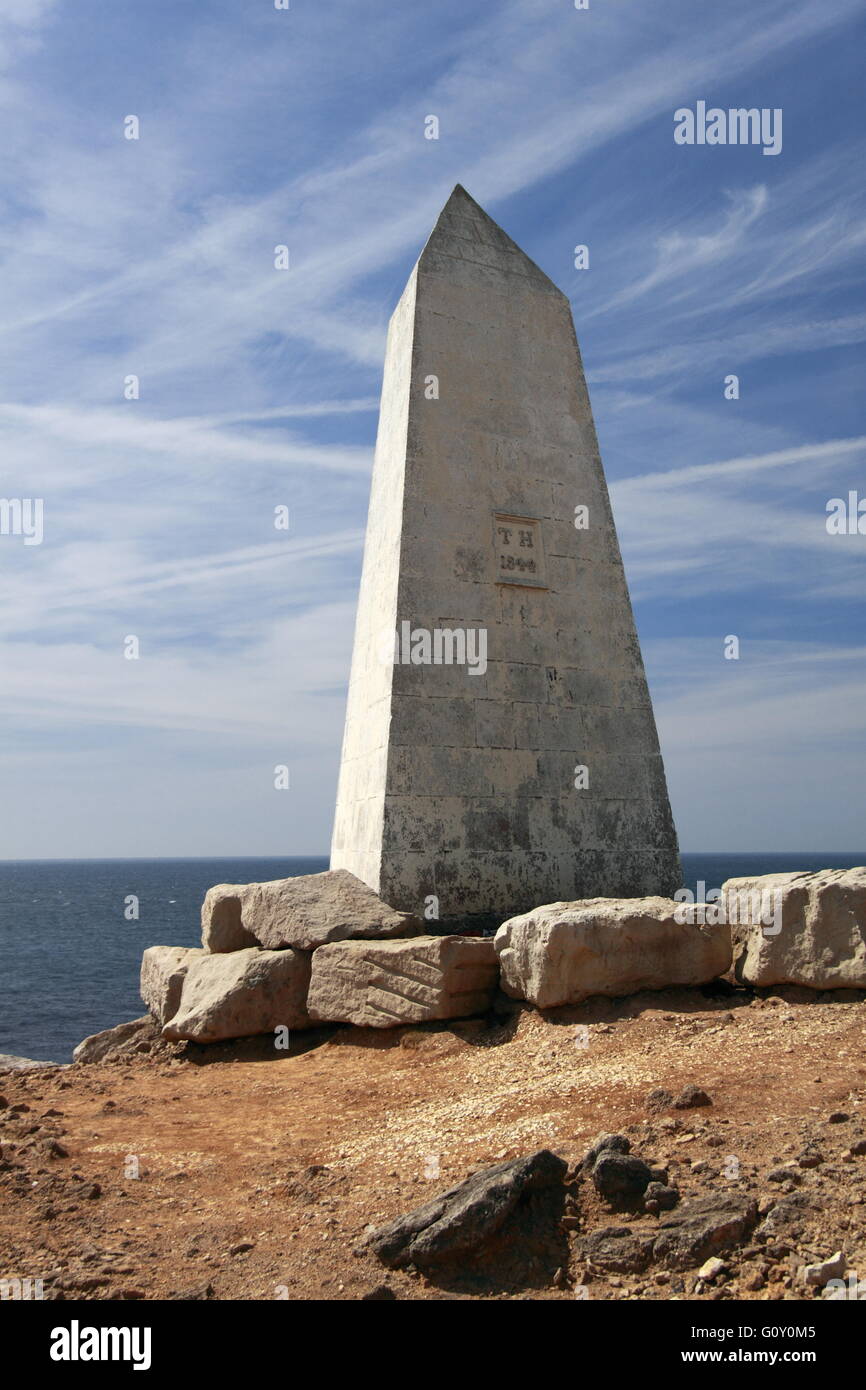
(331, 186, 681, 920)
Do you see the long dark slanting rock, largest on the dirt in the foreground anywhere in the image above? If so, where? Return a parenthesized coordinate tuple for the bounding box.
(360, 1150, 567, 1268)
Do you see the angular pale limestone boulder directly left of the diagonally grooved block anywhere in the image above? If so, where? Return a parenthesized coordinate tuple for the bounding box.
(163, 948, 310, 1043)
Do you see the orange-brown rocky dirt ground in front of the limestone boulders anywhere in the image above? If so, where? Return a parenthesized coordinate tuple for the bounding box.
(0, 987, 866, 1300)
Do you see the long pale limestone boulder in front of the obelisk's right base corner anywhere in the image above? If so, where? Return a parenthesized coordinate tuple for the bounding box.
(495, 898, 731, 1009)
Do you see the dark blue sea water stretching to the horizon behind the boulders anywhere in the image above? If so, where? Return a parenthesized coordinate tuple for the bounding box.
(0, 852, 866, 1062)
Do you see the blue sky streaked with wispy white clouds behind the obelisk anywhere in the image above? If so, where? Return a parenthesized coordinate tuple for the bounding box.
(0, 0, 866, 858)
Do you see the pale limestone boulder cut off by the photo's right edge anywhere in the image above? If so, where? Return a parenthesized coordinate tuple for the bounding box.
(721, 867, 866, 990)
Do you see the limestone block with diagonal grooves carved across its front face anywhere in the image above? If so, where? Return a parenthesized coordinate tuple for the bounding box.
(307, 937, 499, 1029)
